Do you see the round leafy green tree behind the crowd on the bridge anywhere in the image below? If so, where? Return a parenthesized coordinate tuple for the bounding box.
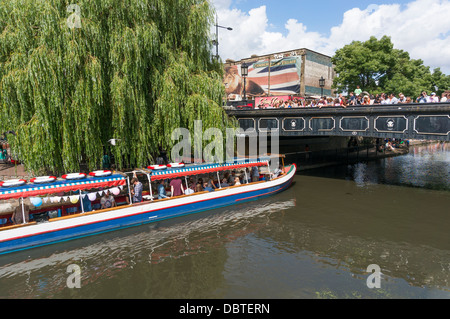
(332, 36, 450, 98)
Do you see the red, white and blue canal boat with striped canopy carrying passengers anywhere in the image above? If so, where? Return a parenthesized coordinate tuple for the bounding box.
(0, 158, 296, 254)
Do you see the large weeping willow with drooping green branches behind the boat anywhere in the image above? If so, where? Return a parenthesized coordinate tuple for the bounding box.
(0, 0, 235, 173)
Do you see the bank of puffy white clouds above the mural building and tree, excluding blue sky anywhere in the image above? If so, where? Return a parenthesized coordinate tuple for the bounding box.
(213, 0, 450, 74)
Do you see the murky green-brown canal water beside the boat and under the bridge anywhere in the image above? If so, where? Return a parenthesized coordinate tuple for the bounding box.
(0, 143, 450, 299)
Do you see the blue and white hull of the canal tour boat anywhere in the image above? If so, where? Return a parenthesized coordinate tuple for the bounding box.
(0, 165, 296, 254)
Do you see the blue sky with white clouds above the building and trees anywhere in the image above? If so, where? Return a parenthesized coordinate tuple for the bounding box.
(211, 0, 450, 74)
